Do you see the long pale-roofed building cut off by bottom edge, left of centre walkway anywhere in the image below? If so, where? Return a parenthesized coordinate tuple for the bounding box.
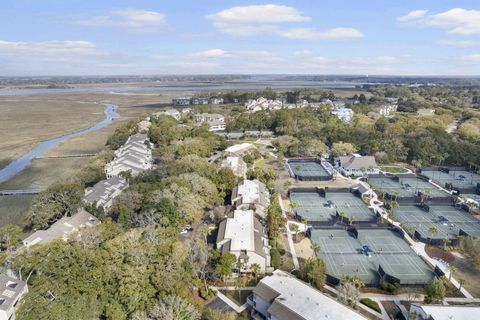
(247, 270, 367, 320)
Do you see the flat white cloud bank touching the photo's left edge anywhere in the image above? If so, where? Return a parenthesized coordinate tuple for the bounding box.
(0, 40, 107, 61)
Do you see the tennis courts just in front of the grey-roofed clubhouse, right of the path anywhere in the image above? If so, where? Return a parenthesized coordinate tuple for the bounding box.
(368, 176, 449, 198)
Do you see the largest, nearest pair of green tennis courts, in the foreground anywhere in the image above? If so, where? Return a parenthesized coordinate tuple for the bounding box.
(311, 229, 433, 286)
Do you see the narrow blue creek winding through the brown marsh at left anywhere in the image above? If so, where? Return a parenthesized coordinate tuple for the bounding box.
(0, 104, 119, 183)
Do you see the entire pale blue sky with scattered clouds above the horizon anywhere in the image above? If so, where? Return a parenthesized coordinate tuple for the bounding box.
(0, 0, 480, 76)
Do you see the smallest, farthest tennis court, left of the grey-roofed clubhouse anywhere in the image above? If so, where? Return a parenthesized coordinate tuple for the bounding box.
(287, 160, 333, 181)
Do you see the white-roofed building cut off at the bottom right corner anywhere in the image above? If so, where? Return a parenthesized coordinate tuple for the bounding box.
(410, 304, 480, 320)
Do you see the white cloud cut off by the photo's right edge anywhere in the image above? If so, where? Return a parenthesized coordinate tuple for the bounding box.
(397, 8, 480, 35)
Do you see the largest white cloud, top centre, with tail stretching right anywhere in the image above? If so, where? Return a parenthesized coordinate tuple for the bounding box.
(207, 4, 363, 40)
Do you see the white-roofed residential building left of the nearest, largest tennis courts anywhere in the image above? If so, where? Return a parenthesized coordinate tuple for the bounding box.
(217, 209, 270, 272)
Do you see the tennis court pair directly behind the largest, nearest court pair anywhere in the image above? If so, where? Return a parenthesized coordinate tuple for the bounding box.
(290, 191, 376, 224)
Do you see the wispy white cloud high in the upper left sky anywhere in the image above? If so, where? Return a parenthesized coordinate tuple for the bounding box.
(77, 9, 166, 32)
